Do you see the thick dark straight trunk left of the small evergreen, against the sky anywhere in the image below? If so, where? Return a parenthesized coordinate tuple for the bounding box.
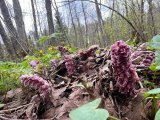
(45, 0, 54, 34)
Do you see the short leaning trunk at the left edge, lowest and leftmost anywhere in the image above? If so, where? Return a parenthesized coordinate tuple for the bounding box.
(0, 21, 16, 60)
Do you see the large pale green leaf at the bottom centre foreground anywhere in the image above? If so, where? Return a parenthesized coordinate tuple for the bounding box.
(69, 98, 109, 120)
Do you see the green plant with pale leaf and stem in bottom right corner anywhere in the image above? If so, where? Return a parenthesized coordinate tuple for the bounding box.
(144, 88, 160, 119)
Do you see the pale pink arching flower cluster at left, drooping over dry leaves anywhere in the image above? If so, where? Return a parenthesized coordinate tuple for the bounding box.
(20, 75, 51, 96)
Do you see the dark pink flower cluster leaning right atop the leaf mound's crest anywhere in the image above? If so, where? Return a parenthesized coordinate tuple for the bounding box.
(79, 45, 98, 60)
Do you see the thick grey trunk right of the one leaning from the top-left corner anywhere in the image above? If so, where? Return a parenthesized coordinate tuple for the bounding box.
(12, 0, 28, 51)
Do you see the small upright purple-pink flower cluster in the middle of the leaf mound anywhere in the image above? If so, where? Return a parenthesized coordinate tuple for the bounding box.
(64, 55, 76, 76)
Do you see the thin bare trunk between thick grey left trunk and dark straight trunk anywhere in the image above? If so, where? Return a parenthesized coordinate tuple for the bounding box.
(31, 0, 39, 40)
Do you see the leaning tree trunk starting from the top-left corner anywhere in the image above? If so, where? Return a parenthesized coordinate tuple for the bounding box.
(0, 0, 27, 57)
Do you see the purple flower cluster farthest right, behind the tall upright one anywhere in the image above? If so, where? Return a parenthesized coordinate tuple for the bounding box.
(141, 52, 154, 66)
